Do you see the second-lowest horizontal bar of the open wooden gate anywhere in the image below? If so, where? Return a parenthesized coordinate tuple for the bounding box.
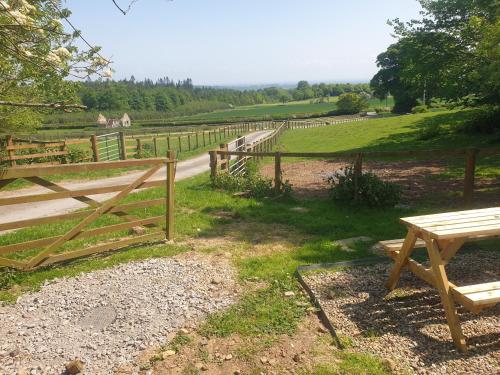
(0, 215, 164, 255)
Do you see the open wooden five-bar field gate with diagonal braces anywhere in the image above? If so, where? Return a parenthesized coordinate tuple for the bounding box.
(0, 153, 175, 270)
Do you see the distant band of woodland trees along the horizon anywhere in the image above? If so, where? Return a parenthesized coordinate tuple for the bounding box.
(46, 76, 370, 123)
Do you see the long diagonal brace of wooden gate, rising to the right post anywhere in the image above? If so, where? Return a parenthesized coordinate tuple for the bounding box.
(27, 165, 161, 267)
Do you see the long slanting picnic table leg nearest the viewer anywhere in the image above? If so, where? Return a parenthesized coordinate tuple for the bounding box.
(426, 240, 467, 352)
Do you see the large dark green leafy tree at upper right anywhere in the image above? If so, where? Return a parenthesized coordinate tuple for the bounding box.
(371, 0, 500, 112)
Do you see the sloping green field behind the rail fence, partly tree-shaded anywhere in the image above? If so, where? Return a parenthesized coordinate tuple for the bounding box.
(278, 110, 500, 152)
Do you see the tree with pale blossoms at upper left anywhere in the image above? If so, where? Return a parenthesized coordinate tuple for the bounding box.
(0, 0, 111, 129)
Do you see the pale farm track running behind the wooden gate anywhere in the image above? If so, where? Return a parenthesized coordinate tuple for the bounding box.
(0, 130, 271, 223)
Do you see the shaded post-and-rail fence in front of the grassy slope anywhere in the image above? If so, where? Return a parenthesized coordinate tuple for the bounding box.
(210, 147, 500, 206)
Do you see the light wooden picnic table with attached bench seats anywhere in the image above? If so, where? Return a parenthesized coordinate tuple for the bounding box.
(381, 207, 500, 352)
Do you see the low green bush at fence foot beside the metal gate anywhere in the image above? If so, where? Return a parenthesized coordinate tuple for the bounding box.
(212, 162, 292, 198)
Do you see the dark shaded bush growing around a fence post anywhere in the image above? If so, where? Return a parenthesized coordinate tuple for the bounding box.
(328, 166, 401, 207)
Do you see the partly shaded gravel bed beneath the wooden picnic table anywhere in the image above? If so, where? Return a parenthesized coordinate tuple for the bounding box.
(305, 251, 500, 375)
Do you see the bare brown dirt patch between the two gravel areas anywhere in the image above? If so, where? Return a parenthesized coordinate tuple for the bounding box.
(148, 313, 337, 375)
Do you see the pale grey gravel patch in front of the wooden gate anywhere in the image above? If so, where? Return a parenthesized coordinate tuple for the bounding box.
(0, 258, 235, 375)
